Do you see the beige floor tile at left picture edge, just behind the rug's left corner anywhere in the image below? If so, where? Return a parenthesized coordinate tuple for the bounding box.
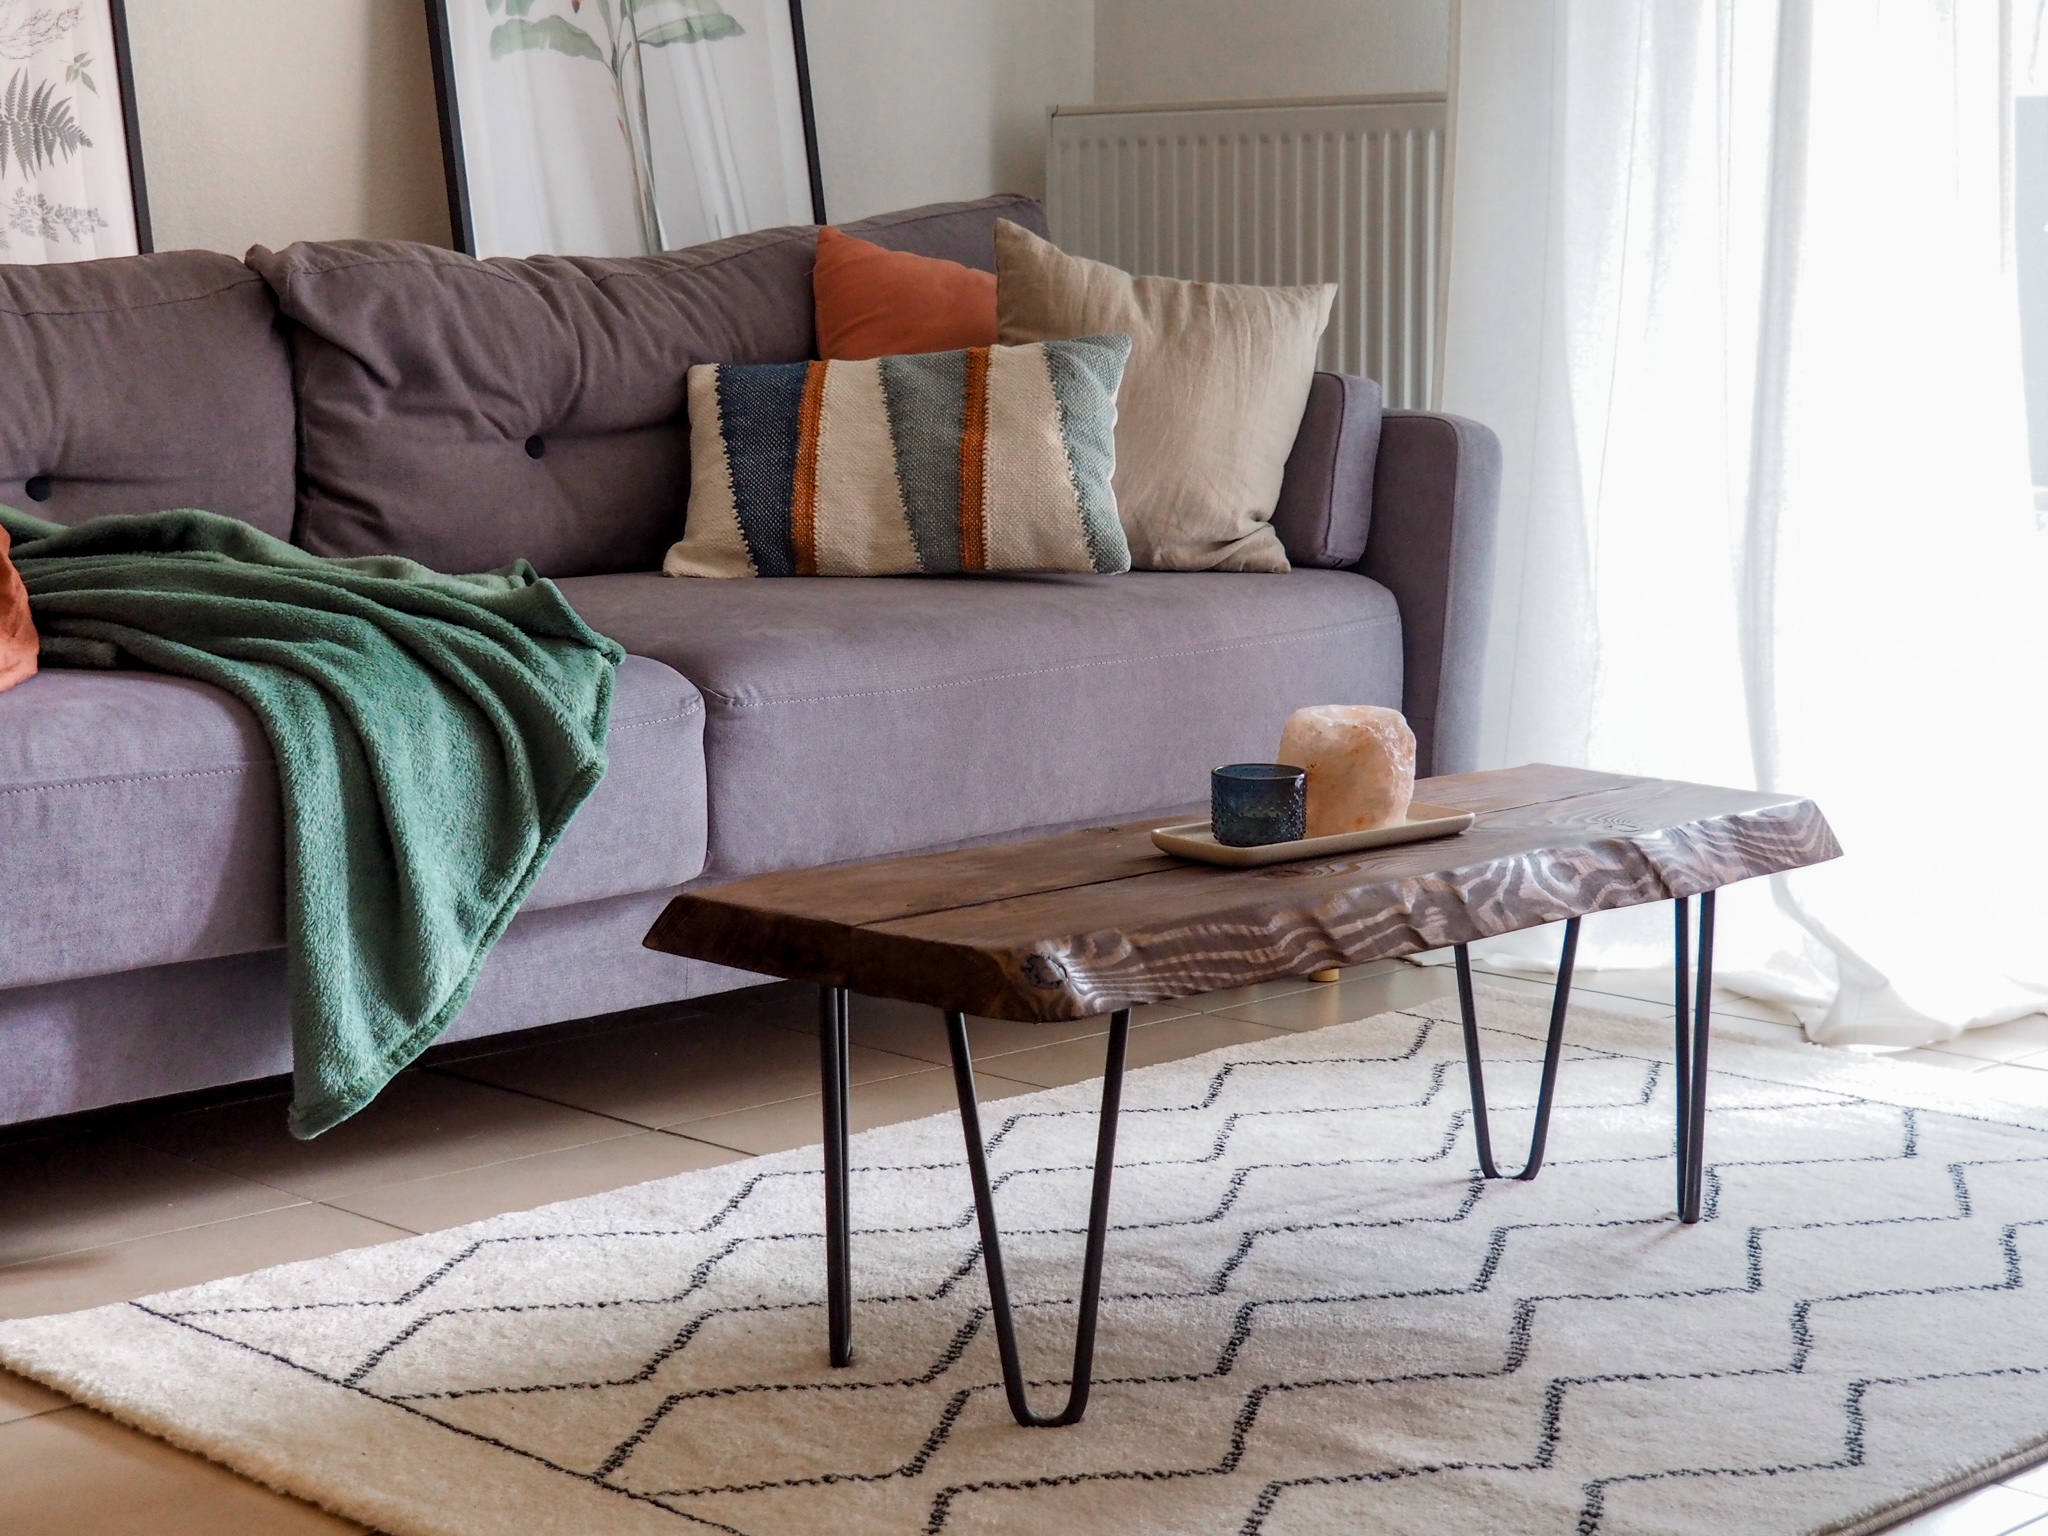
(0, 1204, 412, 1317)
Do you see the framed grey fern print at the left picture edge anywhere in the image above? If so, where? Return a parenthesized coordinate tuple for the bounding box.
(0, 0, 150, 264)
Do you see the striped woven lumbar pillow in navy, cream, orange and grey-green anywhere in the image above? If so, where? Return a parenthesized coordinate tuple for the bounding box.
(662, 336, 1130, 575)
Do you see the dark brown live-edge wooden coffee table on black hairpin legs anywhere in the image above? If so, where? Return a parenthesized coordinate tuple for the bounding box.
(647, 766, 1841, 1425)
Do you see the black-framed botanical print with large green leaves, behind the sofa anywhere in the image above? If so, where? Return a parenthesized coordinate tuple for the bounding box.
(428, 0, 825, 256)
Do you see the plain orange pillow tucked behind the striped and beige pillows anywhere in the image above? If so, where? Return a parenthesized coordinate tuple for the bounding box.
(811, 225, 995, 362)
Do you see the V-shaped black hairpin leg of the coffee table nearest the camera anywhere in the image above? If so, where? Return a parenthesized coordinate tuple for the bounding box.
(946, 1008, 1130, 1430)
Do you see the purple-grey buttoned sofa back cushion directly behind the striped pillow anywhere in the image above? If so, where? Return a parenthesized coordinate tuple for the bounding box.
(248, 197, 1042, 575)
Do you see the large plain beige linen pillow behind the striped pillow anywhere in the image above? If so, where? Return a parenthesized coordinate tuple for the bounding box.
(995, 219, 1337, 571)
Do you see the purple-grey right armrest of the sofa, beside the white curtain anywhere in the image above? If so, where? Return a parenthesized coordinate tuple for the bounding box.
(1354, 412, 1501, 778)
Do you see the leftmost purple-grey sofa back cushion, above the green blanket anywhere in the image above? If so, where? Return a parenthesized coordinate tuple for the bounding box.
(0, 250, 295, 539)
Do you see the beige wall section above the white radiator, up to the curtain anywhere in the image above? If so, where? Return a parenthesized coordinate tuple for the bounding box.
(1096, 0, 1450, 102)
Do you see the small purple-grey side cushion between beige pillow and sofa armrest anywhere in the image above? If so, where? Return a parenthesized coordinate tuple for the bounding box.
(1274, 373, 1380, 569)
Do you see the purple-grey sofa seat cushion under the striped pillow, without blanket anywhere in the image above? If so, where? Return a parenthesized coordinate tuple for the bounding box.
(561, 571, 1401, 877)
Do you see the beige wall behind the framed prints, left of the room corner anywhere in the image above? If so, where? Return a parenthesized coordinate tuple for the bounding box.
(129, 0, 1096, 256)
